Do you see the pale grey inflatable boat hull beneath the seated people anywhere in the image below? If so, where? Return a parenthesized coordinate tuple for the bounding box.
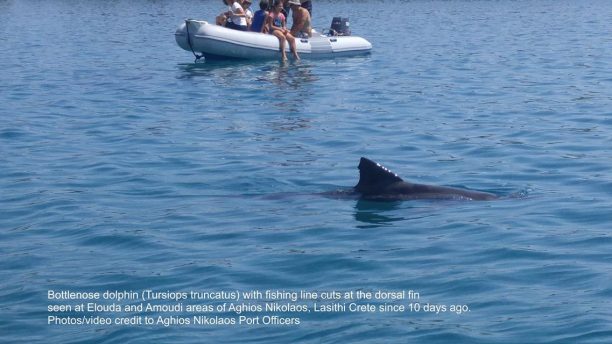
(174, 19, 372, 60)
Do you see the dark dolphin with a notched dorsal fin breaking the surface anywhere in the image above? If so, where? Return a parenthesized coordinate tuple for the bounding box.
(353, 157, 497, 201)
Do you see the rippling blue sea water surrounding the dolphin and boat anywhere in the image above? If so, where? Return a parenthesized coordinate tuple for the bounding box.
(0, 0, 612, 343)
